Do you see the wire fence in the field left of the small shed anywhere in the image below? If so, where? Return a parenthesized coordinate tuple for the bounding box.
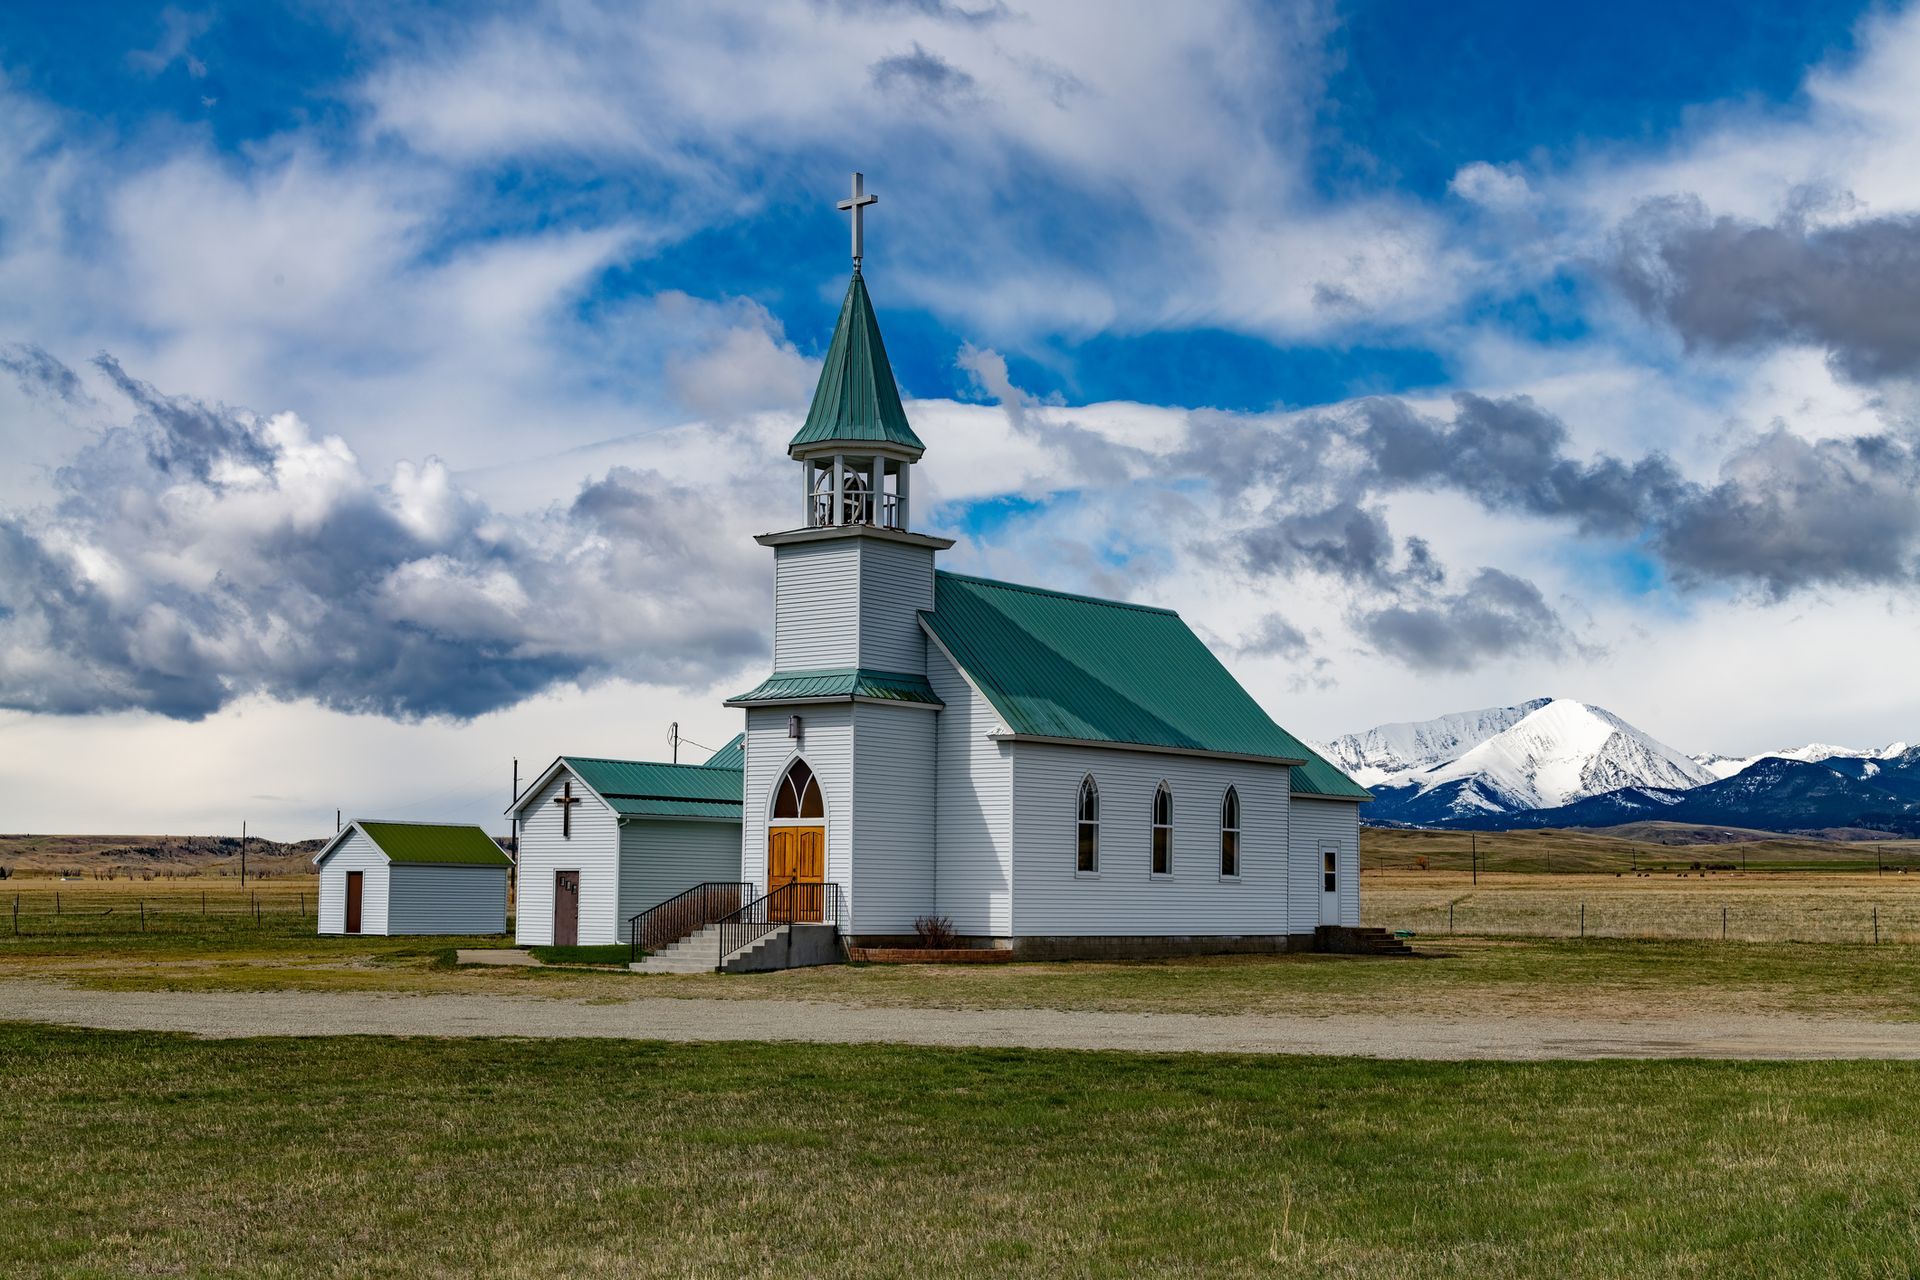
(0, 887, 315, 938)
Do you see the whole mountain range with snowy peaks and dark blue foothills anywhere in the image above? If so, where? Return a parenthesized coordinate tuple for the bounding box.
(1321, 699, 1920, 835)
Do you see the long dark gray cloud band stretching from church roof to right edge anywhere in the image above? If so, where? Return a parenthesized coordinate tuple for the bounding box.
(1173, 395, 1920, 599)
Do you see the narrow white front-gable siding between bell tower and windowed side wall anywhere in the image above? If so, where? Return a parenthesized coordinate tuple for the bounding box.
(927, 645, 1014, 938)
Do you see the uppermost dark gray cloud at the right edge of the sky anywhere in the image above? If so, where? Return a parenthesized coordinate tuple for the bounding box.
(1611, 198, 1920, 382)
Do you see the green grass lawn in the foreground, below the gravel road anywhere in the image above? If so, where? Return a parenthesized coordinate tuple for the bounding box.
(0, 1027, 1920, 1278)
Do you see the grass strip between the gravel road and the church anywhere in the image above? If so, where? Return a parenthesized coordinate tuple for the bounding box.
(18, 929, 1920, 1021)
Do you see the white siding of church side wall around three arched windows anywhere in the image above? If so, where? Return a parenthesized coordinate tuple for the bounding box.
(1014, 743, 1288, 936)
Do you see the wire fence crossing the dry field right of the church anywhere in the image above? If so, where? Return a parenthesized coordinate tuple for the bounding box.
(1361, 890, 1920, 944)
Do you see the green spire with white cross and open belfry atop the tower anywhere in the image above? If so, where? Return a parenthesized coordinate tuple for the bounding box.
(787, 173, 927, 530)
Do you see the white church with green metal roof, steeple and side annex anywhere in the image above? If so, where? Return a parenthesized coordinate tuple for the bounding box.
(511, 177, 1369, 967)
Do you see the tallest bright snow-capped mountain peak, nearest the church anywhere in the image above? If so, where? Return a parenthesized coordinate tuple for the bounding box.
(1327, 699, 1713, 823)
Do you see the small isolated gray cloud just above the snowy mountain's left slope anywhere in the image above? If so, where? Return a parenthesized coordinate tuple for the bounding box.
(1352, 568, 1584, 672)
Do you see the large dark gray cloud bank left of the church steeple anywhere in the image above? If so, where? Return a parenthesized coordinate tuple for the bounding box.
(0, 357, 766, 720)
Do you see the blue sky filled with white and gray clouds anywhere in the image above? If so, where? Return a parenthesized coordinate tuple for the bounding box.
(0, 0, 1920, 827)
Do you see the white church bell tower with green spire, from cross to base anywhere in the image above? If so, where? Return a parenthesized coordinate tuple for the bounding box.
(728, 173, 952, 936)
